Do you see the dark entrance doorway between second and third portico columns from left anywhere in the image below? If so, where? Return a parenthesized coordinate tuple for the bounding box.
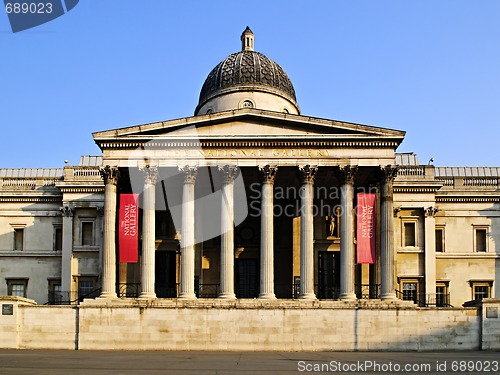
(155, 251, 177, 298)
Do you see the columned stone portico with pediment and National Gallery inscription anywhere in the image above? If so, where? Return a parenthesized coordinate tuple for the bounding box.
(94, 109, 404, 300)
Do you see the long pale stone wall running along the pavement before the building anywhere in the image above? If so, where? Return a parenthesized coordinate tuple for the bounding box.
(0, 297, 500, 351)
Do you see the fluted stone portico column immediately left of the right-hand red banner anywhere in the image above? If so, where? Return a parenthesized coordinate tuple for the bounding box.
(338, 165, 358, 300)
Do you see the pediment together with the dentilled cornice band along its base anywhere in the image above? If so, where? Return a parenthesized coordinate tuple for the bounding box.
(93, 109, 405, 148)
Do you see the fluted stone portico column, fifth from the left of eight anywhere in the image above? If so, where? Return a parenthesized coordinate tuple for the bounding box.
(259, 165, 278, 299)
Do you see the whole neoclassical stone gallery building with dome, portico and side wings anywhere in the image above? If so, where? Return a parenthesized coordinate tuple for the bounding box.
(0, 28, 500, 307)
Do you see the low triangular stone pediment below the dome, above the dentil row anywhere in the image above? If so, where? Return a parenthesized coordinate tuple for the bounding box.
(93, 109, 405, 145)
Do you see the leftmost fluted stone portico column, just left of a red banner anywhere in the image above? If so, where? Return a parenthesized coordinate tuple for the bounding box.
(100, 165, 120, 298)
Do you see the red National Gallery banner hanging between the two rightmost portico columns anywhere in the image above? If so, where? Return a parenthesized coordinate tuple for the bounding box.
(356, 193, 376, 264)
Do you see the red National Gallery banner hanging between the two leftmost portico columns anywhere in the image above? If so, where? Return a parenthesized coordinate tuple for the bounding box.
(118, 194, 139, 263)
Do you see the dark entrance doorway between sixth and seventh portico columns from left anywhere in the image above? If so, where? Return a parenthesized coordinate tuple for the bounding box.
(318, 251, 340, 299)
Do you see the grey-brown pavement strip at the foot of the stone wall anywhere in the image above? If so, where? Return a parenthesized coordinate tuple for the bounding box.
(0, 350, 500, 375)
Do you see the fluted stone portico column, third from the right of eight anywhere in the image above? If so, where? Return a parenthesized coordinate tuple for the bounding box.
(299, 165, 318, 299)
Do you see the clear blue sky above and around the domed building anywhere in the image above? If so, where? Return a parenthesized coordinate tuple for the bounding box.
(0, 0, 500, 167)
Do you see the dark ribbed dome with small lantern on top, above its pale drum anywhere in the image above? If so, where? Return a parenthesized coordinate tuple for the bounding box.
(196, 27, 298, 111)
